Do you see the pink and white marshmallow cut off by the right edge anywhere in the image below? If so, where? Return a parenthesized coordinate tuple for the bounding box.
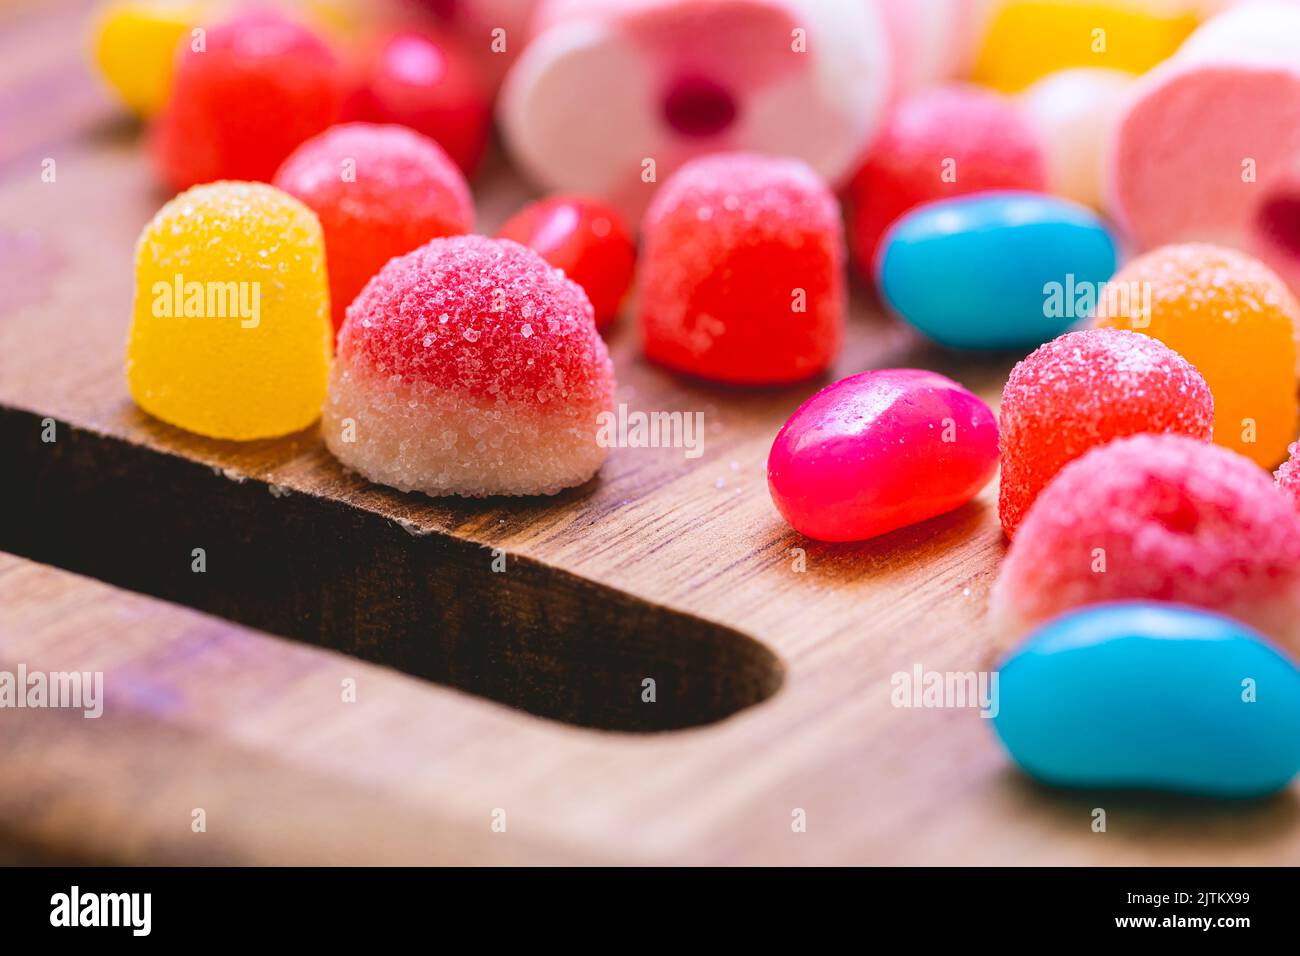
(1108, 0, 1300, 289)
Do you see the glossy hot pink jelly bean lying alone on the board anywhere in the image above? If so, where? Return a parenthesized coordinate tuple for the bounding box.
(767, 368, 997, 541)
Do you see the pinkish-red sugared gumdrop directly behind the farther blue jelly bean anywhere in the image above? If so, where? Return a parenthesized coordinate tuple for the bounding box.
(848, 83, 1047, 276)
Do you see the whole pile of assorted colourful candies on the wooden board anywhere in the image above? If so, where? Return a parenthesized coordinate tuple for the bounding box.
(95, 0, 1300, 796)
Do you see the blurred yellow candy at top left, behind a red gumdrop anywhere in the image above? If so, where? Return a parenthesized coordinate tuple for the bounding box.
(94, 0, 202, 117)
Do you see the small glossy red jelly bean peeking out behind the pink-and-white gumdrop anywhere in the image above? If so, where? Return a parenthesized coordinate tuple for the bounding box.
(497, 196, 637, 328)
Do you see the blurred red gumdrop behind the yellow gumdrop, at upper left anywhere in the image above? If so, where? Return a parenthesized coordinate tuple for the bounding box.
(152, 10, 342, 190)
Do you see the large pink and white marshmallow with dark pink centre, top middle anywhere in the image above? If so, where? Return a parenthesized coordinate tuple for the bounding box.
(499, 0, 894, 215)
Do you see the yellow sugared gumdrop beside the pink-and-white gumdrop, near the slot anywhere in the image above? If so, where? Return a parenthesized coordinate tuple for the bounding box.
(126, 182, 333, 440)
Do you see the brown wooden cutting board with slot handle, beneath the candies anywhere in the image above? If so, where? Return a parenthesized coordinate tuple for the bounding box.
(0, 1, 1300, 864)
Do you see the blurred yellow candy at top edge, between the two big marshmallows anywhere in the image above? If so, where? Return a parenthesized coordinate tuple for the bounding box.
(975, 0, 1199, 92)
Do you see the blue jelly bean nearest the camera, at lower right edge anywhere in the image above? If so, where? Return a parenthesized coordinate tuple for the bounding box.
(993, 601, 1300, 797)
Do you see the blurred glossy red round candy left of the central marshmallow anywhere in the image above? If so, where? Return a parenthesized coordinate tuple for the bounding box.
(343, 31, 491, 176)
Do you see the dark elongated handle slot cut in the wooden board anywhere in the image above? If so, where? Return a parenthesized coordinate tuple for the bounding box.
(0, 408, 783, 731)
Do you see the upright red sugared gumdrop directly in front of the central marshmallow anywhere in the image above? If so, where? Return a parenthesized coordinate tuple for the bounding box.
(640, 153, 845, 385)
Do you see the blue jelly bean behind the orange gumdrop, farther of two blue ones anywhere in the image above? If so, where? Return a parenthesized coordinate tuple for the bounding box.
(876, 193, 1115, 349)
